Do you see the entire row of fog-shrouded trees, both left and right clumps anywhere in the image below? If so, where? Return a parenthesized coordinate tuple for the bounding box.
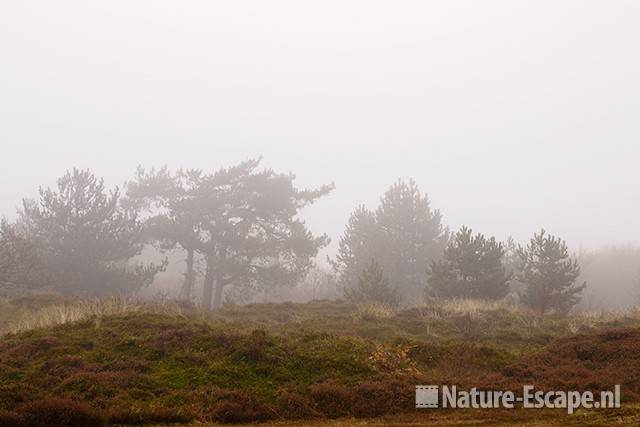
(0, 159, 585, 313)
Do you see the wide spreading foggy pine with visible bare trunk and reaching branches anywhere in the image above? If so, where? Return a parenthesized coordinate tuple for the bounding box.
(131, 160, 333, 308)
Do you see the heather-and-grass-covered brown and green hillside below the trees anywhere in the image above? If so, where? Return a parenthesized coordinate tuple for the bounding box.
(0, 296, 640, 426)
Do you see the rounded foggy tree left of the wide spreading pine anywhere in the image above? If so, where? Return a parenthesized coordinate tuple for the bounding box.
(19, 169, 162, 295)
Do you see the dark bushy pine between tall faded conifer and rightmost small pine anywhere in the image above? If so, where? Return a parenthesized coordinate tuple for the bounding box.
(428, 227, 510, 299)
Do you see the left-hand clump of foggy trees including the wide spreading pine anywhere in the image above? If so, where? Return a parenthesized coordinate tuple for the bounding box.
(0, 160, 332, 307)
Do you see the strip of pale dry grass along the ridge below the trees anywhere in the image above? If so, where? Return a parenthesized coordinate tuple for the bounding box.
(0, 294, 640, 344)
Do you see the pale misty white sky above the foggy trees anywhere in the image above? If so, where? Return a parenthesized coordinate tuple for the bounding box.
(0, 0, 640, 258)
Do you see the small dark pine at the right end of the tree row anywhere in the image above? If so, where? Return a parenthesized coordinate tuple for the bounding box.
(518, 230, 587, 314)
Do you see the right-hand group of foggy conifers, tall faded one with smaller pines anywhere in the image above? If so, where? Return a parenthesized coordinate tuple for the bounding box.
(331, 181, 586, 314)
